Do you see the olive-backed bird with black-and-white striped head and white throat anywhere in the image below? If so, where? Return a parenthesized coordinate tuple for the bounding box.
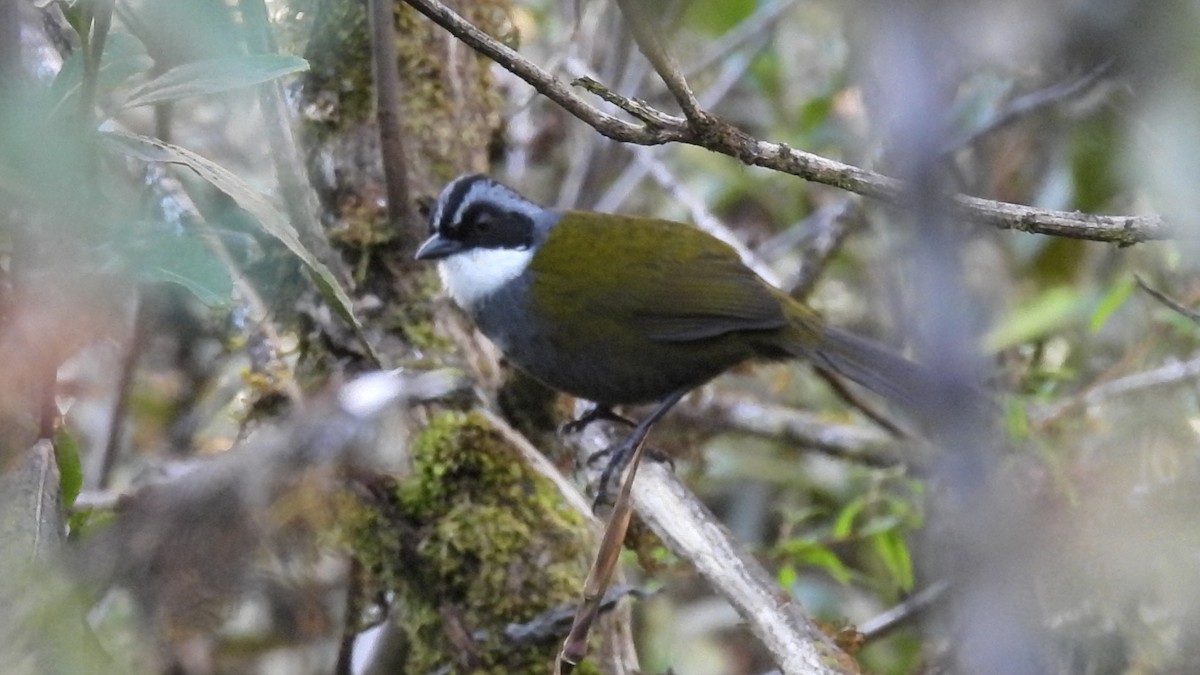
(415, 174, 938, 486)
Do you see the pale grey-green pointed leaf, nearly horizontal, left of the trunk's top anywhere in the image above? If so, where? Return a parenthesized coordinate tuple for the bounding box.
(120, 54, 308, 109)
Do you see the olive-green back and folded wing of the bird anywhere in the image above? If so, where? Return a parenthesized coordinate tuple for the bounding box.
(533, 211, 787, 341)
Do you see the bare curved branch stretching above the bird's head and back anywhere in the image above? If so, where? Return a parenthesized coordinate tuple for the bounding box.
(404, 0, 1174, 246)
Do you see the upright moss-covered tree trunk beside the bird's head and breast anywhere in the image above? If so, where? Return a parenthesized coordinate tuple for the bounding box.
(301, 0, 628, 673)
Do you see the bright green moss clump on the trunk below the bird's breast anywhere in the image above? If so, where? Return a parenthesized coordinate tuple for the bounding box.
(347, 412, 593, 673)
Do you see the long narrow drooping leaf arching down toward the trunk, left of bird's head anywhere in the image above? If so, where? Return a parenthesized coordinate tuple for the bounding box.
(102, 131, 379, 363)
